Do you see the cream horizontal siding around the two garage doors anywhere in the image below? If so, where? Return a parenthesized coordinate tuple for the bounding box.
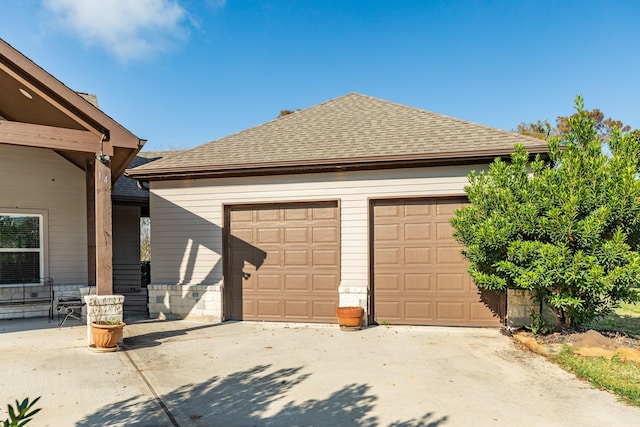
(151, 166, 476, 288)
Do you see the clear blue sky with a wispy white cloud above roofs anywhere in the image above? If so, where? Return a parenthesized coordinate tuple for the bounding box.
(0, 0, 640, 151)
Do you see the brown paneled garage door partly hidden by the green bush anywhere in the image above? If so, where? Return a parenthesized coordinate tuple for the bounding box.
(372, 199, 504, 326)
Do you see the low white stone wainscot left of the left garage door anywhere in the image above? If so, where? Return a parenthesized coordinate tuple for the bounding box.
(147, 285, 222, 323)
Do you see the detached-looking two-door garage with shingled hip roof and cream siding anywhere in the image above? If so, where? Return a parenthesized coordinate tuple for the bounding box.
(128, 93, 548, 326)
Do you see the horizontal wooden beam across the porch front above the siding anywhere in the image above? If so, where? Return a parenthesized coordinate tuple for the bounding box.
(0, 120, 100, 153)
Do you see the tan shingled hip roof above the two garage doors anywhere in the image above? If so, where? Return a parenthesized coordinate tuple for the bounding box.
(127, 93, 547, 180)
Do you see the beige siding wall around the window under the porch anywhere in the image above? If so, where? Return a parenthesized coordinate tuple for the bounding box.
(0, 144, 87, 285)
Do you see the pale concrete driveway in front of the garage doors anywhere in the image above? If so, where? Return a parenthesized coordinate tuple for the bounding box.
(0, 319, 640, 427)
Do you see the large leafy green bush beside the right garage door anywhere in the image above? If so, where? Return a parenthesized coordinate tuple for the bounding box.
(451, 97, 640, 328)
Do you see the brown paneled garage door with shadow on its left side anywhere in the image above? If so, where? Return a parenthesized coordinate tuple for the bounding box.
(226, 202, 340, 322)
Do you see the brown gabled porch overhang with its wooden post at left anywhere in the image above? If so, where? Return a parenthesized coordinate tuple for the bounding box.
(0, 39, 145, 295)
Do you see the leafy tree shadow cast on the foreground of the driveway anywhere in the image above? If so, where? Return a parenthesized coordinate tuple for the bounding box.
(76, 365, 448, 427)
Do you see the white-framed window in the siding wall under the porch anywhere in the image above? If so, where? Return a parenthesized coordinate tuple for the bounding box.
(0, 213, 44, 285)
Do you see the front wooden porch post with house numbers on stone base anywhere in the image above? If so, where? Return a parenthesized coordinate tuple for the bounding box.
(93, 155, 113, 295)
